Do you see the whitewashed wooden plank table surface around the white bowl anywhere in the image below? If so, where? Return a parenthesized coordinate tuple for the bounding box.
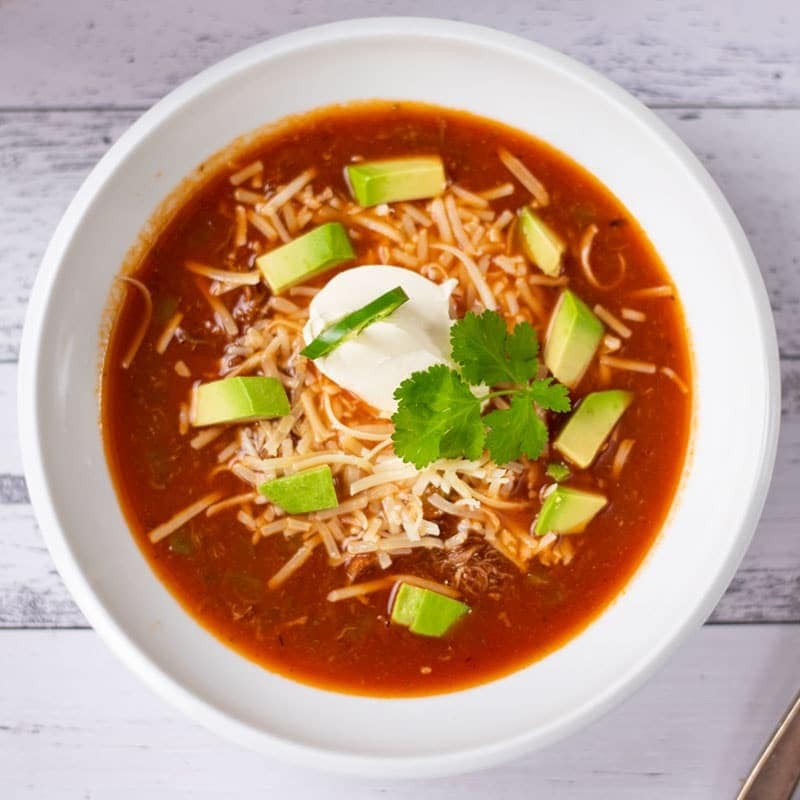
(0, 0, 800, 800)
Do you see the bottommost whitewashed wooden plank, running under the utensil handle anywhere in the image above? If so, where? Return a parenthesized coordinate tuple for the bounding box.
(0, 625, 800, 800)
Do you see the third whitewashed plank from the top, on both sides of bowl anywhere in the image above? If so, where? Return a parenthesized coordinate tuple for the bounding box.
(0, 360, 800, 628)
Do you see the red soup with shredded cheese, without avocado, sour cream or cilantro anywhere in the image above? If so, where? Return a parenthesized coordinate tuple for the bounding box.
(102, 103, 692, 696)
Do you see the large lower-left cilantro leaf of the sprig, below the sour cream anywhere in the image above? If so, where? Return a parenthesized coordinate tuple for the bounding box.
(392, 364, 486, 469)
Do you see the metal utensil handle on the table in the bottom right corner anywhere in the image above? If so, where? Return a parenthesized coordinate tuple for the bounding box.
(736, 694, 800, 800)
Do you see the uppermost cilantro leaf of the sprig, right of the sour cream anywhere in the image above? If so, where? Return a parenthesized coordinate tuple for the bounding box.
(450, 311, 539, 386)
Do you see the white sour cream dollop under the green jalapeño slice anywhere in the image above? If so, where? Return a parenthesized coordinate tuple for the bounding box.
(303, 264, 456, 414)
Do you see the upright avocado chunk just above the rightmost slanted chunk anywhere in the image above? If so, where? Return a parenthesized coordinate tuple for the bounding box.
(544, 289, 604, 389)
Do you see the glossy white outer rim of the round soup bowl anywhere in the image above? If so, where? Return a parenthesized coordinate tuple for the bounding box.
(17, 17, 780, 777)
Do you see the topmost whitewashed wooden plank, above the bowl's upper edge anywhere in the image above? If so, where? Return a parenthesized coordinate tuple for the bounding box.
(0, 0, 800, 107)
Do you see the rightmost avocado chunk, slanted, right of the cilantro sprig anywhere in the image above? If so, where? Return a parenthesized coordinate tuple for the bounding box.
(553, 389, 633, 469)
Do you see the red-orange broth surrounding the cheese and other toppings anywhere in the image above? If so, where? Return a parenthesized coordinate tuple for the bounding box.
(102, 103, 692, 696)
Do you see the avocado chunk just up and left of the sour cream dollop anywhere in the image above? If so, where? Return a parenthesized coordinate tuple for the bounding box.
(256, 222, 355, 294)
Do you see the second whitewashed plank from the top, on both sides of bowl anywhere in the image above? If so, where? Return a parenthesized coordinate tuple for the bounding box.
(0, 107, 800, 360)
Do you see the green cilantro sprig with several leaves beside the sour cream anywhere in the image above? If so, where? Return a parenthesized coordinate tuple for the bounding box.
(392, 311, 570, 469)
